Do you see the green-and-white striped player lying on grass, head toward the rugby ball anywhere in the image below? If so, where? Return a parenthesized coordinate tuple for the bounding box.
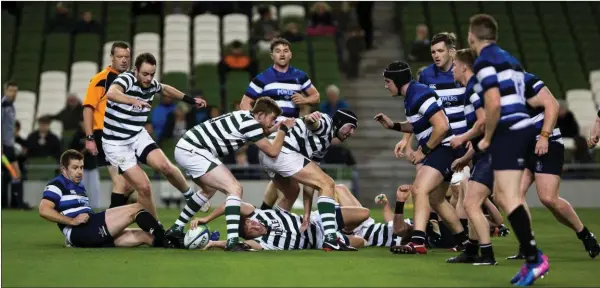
(190, 202, 368, 251)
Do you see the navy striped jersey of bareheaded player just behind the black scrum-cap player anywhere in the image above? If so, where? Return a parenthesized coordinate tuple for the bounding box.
(419, 64, 468, 135)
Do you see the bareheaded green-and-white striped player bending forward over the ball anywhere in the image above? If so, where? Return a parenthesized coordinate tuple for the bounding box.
(166, 97, 294, 251)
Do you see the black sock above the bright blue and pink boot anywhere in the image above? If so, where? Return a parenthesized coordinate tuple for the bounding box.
(508, 205, 538, 263)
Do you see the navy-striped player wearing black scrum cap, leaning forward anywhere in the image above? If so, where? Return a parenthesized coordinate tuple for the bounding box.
(374, 62, 467, 254)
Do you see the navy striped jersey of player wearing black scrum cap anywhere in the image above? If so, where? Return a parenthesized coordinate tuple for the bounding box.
(404, 80, 454, 146)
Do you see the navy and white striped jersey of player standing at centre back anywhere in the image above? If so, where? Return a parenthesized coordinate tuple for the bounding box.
(246, 66, 312, 117)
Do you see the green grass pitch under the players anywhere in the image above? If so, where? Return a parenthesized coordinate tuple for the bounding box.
(2, 209, 600, 287)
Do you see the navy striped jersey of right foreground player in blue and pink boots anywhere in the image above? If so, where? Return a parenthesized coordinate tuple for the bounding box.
(473, 43, 531, 130)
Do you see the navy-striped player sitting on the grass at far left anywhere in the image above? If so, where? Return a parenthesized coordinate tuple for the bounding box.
(39, 150, 164, 248)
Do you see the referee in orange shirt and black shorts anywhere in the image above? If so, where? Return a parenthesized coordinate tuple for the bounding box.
(83, 41, 132, 208)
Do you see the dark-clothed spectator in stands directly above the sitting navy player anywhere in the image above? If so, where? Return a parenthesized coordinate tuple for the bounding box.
(27, 115, 61, 163)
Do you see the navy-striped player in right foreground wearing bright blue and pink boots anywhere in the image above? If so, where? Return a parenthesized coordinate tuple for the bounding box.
(468, 14, 549, 286)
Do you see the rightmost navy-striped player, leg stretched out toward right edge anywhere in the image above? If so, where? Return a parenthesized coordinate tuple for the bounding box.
(507, 73, 600, 259)
